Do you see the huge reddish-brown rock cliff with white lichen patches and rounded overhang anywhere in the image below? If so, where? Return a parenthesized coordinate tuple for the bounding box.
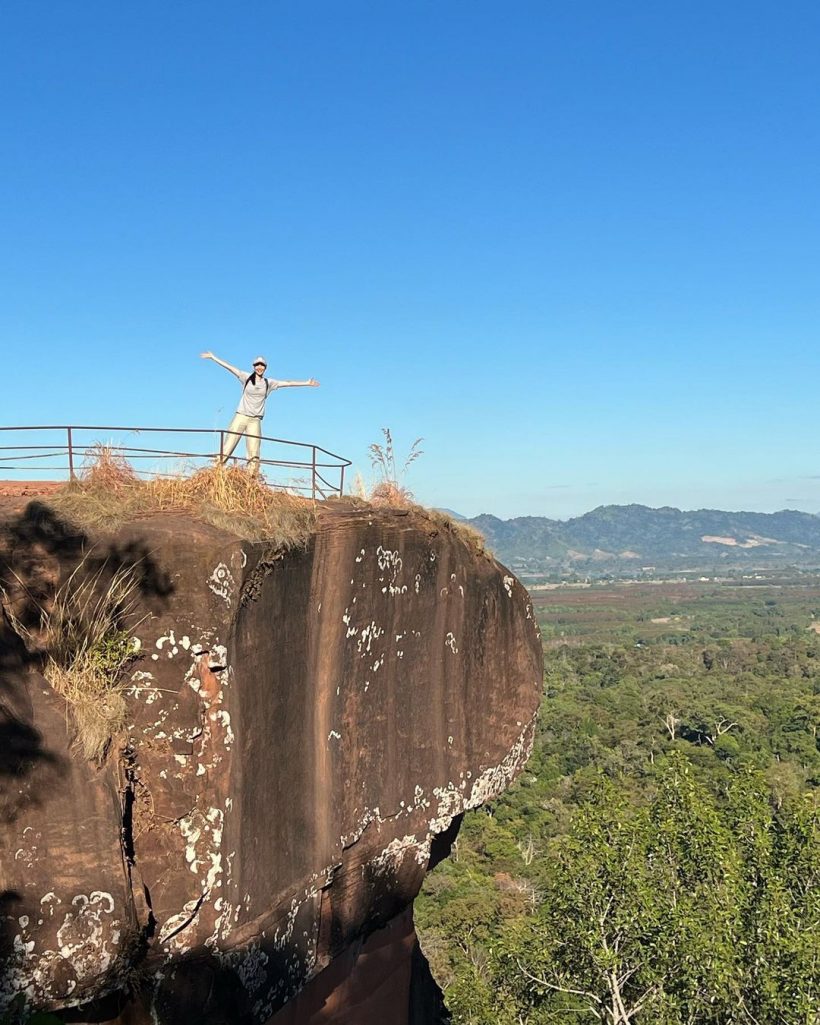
(0, 499, 541, 1025)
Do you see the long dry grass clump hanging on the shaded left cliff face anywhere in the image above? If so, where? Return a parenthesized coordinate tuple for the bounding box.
(3, 558, 141, 762)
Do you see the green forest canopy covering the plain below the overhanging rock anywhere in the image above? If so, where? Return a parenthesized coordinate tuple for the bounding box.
(416, 584, 820, 1025)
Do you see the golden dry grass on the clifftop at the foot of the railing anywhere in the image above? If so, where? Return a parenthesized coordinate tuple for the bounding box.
(48, 446, 316, 549)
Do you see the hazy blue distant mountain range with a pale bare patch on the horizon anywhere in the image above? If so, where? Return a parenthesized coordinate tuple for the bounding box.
(466, 505, 820, 573)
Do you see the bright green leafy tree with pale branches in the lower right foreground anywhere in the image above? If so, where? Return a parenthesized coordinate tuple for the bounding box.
(505, 756, 820, 1025)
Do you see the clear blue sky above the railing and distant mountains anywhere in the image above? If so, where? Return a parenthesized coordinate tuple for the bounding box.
(0, 0, 820, 517)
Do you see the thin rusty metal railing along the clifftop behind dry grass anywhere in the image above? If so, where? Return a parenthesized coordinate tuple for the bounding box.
(0, 424, 351, 498)
